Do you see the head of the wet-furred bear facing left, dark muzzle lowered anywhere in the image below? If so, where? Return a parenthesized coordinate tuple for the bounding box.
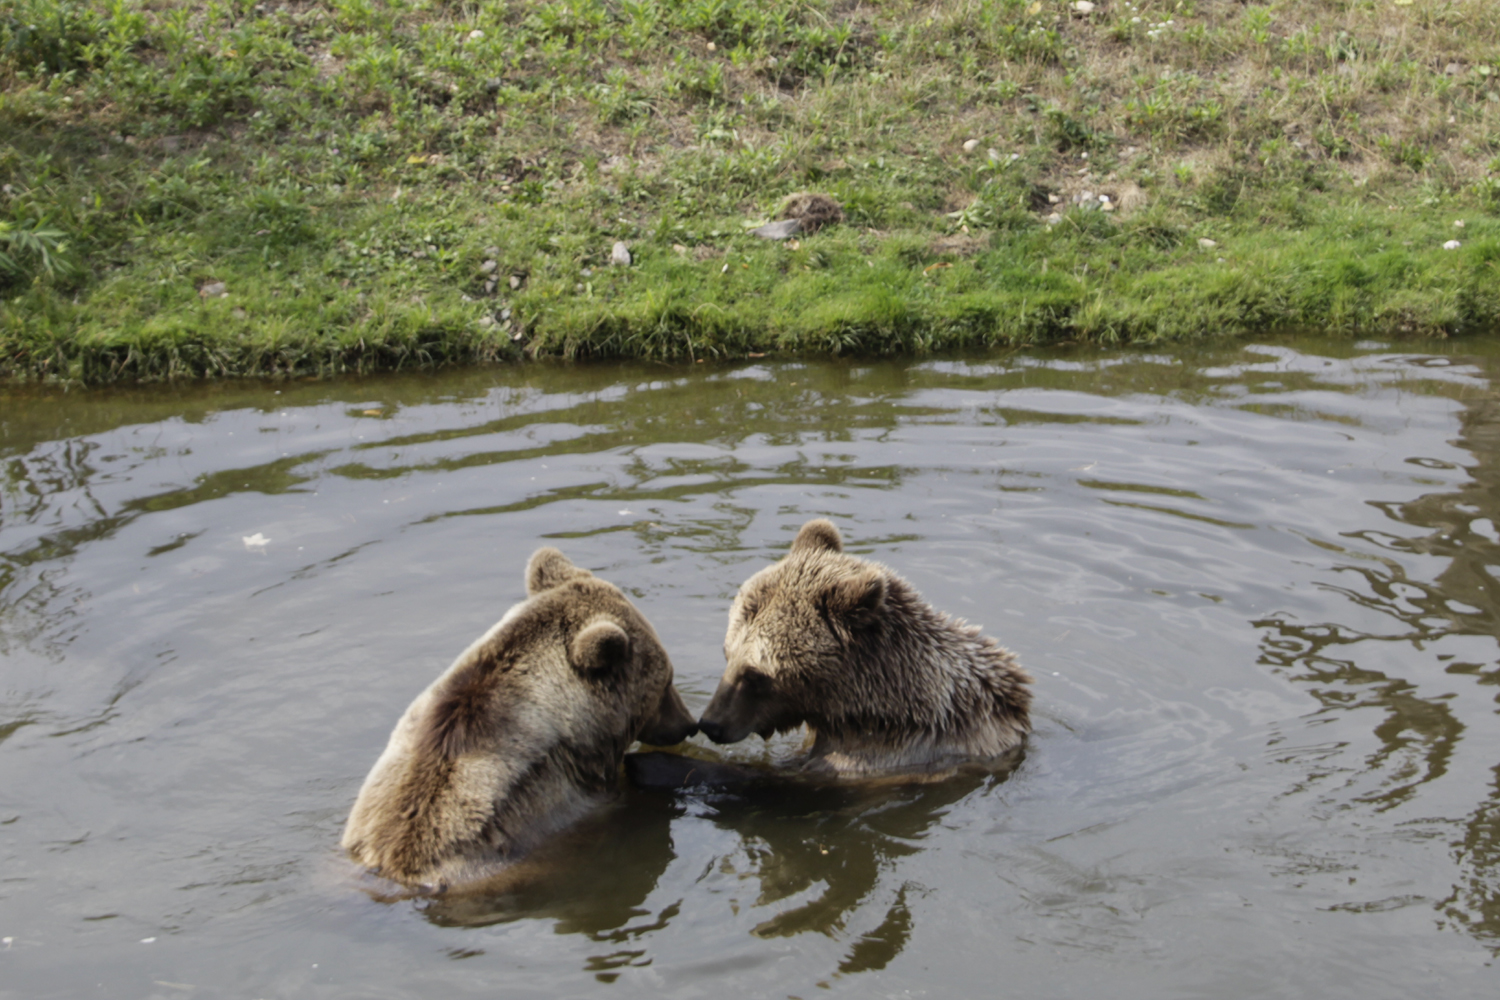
(698, 519, 887, 744)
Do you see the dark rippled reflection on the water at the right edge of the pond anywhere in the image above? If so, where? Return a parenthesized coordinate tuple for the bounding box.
(1253, 358, 1500, 954)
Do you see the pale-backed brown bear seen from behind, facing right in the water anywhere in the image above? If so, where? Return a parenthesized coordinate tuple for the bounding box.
(342, 549, 698, 892)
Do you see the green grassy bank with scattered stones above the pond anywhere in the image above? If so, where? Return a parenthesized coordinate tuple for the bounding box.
(0, 0, 1500, 381)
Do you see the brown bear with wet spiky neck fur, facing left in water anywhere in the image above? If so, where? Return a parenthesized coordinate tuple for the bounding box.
(698, 519, 1031, 777)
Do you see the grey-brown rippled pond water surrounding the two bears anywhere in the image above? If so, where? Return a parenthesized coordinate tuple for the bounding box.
(0, 340, 1500, 1000)
